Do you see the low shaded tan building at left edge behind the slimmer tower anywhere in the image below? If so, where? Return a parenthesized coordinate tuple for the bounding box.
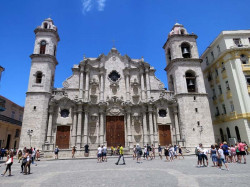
(0, 96, 24, 149)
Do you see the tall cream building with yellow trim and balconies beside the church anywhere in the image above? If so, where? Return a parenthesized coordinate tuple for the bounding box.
(201, 30, 250, 144)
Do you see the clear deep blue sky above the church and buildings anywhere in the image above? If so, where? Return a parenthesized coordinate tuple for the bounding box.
(0, 0, 250, 106)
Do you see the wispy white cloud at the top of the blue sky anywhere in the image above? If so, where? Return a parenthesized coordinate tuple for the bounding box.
(82, 0, 106, 14)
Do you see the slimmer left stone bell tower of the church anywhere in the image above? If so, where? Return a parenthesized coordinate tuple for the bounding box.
(19, 18, 60, 149)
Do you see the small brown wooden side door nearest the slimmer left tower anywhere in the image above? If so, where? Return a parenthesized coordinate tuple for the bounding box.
(56, 126, 70, 149)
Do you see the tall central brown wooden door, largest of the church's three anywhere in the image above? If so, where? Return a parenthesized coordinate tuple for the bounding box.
(106, 116, 125, 147)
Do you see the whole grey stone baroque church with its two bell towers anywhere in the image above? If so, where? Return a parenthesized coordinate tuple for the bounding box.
(20, 18, 214, 156)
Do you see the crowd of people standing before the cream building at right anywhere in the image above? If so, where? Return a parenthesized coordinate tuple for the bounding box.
(195, 141, 248, 170)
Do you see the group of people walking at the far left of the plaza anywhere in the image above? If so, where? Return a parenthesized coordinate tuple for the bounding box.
(1, 147, 40, 176)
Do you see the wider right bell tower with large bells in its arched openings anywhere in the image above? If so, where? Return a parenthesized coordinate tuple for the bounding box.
(163, 23, 215, 151)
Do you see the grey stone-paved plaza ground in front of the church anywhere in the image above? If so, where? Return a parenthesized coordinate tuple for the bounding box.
(0, 156, 250, 187)
